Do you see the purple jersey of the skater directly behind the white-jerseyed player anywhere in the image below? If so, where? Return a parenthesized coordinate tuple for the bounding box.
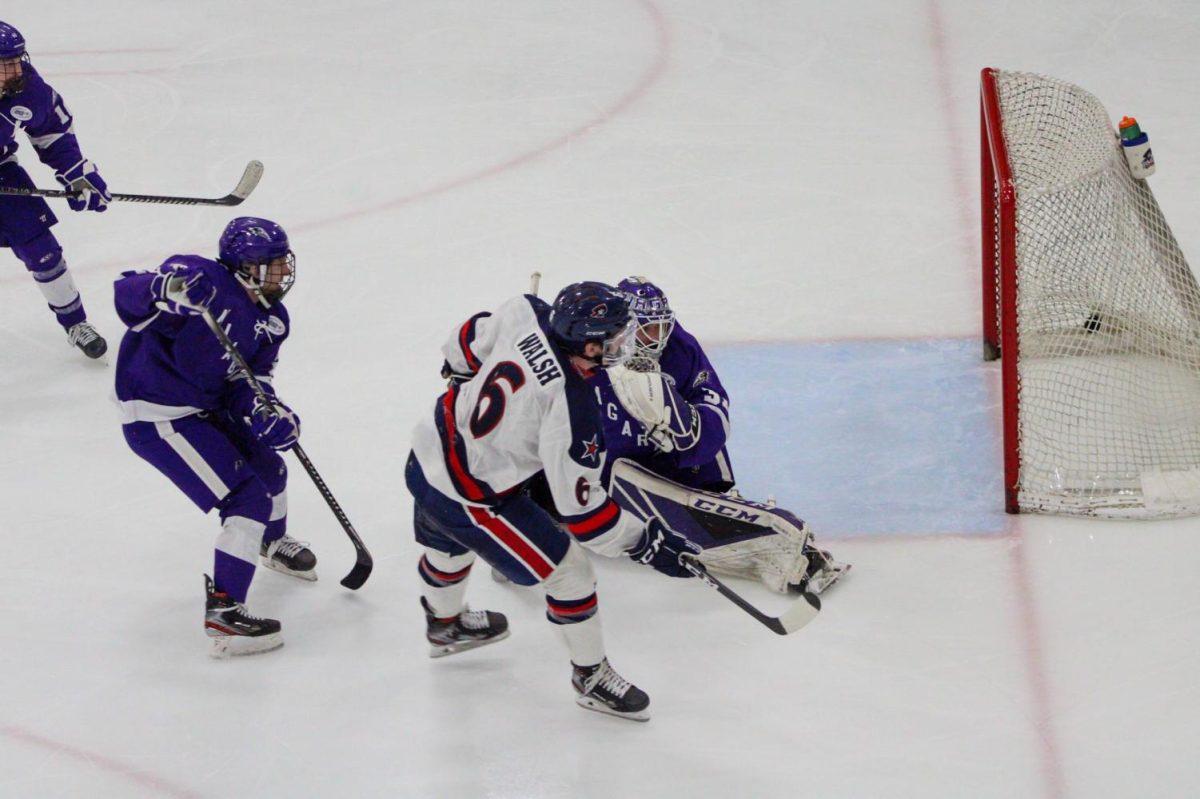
(113, 256, 290, 422)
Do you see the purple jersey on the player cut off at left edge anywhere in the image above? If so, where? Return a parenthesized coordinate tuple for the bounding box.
(0, 64, 83, 172)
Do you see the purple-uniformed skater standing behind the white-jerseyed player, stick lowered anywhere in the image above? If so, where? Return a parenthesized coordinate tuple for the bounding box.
(114, 217, 317, 656)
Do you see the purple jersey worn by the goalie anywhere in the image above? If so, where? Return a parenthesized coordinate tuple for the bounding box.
(595, 323, 734, 488)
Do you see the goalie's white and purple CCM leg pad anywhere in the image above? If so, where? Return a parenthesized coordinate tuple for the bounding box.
(610, 458, 810, 594)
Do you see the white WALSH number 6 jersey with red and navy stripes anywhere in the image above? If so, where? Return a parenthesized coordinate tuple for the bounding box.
(413, 295, 642, 555)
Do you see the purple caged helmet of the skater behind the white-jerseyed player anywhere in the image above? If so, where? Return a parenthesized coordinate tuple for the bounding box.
(217, 216, 296, 307)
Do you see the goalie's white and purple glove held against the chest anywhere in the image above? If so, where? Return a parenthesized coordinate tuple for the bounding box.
(608, 366, 700, 452)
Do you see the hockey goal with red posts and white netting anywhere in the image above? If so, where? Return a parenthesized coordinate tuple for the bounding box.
(980, 68, 1200, 518)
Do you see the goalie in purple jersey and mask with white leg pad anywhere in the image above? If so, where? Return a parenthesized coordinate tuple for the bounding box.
(595, 277, 850, 594)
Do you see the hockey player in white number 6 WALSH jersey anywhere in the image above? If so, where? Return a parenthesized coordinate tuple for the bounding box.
(404, 282, 696, 721)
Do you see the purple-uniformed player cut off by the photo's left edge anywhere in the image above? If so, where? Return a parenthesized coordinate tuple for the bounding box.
(0, 22, 112, 358)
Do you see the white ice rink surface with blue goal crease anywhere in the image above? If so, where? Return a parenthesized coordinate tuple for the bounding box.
(0, 0, 1200, 799)
